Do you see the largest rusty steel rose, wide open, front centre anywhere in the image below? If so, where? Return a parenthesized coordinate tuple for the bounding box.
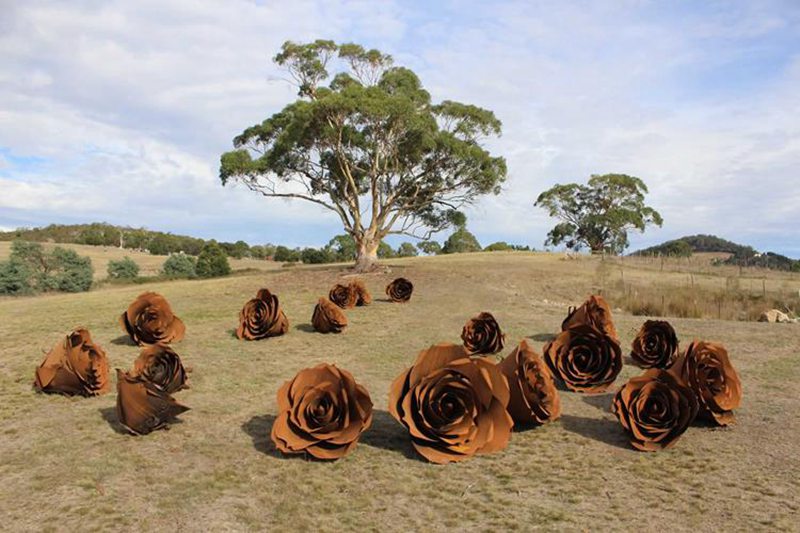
(389, 343, 514, 464)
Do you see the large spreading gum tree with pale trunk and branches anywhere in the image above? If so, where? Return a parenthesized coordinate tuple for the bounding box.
(220, 40, 506, 270)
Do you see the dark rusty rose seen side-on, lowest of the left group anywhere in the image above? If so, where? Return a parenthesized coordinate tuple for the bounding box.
(117, 369, 189, 435)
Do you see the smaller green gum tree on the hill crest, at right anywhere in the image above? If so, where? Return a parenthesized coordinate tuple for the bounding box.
(534, 174, 663, 254)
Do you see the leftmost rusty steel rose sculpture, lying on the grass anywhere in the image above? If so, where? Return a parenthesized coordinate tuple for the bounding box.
(33, 328, 111, 396)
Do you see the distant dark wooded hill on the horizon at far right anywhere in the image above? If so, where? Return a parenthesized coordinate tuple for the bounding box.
(631, 235, 800, 272)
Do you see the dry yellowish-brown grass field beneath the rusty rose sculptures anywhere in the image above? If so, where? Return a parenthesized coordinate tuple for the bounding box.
(0, 253, 800, 531)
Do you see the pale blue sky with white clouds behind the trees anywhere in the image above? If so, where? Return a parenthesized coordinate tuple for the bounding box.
(0, 0, 800, 257)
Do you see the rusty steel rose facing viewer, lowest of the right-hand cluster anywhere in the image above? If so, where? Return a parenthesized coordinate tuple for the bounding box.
(611, 368, 697, 452)
